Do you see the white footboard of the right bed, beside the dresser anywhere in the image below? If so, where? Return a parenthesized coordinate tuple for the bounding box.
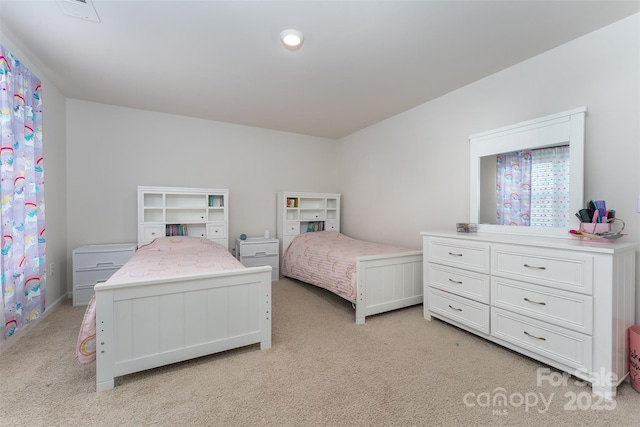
(356, 251, 423, 324)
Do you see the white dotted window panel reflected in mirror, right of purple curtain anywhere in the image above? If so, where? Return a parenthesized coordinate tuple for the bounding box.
(531, 145, 570, 228)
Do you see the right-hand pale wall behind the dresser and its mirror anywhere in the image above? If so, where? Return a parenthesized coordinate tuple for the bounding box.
(338, 15, 640, 319)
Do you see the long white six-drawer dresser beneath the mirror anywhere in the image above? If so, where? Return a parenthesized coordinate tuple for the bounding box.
(421, 232, 637, 398)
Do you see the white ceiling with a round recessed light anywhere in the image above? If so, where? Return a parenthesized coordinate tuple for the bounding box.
(0, 0, 640, 139)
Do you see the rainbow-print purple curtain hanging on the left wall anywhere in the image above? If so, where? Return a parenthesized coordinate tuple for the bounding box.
(0, 45, 46, 338)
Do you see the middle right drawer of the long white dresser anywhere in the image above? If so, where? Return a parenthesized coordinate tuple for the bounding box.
(491, 277, 593, 335)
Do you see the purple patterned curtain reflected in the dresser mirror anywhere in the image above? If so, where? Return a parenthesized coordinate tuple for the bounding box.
(496, 150, 531, 225)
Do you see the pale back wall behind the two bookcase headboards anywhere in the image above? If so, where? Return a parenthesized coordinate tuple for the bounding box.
(67, 99, 337, 282)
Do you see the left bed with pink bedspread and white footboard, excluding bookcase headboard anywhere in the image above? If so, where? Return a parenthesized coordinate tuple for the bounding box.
(76, 236, 271, 391)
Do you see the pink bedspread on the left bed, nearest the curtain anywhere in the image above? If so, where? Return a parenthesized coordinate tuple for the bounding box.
(76, 236, 245, 365)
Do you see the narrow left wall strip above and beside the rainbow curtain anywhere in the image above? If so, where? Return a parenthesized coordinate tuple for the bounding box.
(0, 31, 67, 312)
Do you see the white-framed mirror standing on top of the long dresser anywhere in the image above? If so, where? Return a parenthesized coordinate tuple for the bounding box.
(469, 107, 587, 236)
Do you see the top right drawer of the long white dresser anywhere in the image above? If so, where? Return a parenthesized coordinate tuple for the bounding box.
(491, 245, 593, 295)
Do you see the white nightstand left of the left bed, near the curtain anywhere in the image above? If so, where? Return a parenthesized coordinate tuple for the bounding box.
(72, 243, 137, 305)
